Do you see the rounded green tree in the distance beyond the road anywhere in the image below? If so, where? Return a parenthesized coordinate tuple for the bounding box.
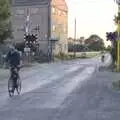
(85, 35, 104, 51)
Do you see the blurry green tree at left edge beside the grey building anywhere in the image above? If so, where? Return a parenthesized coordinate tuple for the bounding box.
(0, 0, 12, 43)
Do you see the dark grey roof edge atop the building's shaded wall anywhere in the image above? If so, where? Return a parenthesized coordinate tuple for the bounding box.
(12, 0, 51, 6)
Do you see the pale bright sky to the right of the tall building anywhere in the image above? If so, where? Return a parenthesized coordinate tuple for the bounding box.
(66, 0, 117, 46)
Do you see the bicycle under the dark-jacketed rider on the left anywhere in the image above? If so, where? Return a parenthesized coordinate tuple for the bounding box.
(8, 67, 21, 97)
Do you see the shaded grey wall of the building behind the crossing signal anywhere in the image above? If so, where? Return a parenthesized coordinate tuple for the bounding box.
(12, 5, 48, 53)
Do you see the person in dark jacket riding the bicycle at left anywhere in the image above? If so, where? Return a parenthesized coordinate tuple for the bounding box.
(6, 46, 20, 78)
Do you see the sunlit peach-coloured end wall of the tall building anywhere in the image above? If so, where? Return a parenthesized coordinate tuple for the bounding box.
(51, 0, 68, 53)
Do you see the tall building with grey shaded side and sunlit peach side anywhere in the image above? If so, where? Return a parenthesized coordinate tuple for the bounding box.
(11, 0, 68, 53)
